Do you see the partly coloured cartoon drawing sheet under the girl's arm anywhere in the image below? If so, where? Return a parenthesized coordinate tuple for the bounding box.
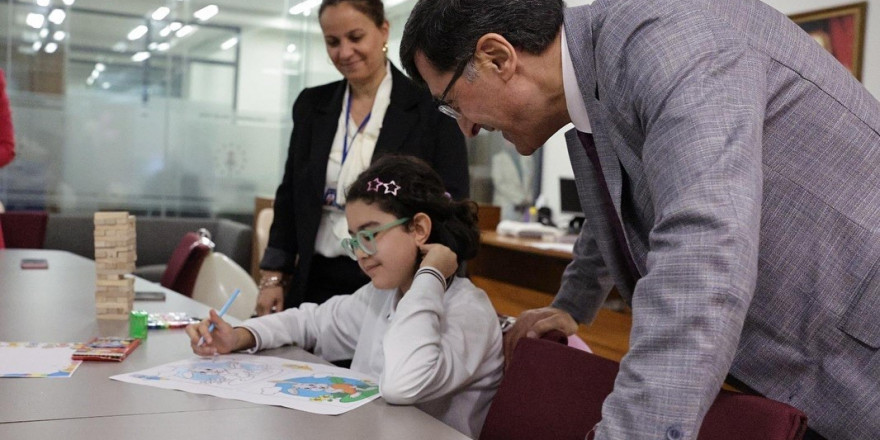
(111, 354, 379, 414)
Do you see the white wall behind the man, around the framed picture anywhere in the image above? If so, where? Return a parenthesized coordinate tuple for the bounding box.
(541, 0, 880, 221)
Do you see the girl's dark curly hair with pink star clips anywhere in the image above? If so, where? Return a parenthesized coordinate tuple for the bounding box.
(346, 155, 480, 264)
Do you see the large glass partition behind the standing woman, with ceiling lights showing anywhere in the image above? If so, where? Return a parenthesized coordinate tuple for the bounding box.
(0, 0, 539, 222)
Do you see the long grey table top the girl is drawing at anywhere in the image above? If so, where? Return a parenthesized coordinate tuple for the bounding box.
(0, 249, 467, 440)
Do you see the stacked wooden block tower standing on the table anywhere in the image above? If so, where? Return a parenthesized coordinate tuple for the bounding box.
(95, 212, 137, 319)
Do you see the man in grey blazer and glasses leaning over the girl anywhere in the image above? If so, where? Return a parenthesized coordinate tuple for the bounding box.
(401, 0, 880, 440)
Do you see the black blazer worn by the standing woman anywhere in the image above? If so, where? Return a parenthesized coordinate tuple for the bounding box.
(260, 65, 470, 306)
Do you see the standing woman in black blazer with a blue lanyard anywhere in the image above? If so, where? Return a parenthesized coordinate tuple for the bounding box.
(257, 0, 470, 315)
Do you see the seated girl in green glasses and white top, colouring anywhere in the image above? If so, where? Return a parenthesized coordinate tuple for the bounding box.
(187, 156, 504, 437)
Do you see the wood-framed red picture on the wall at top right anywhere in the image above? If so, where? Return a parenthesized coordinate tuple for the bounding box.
(789, 2, 868, 81)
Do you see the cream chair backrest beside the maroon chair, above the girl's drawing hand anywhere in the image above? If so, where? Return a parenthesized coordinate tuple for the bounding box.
(192, 252, 259, 319)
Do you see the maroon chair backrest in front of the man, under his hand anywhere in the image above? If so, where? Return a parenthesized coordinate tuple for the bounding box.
(480, 332, 806, 440)
